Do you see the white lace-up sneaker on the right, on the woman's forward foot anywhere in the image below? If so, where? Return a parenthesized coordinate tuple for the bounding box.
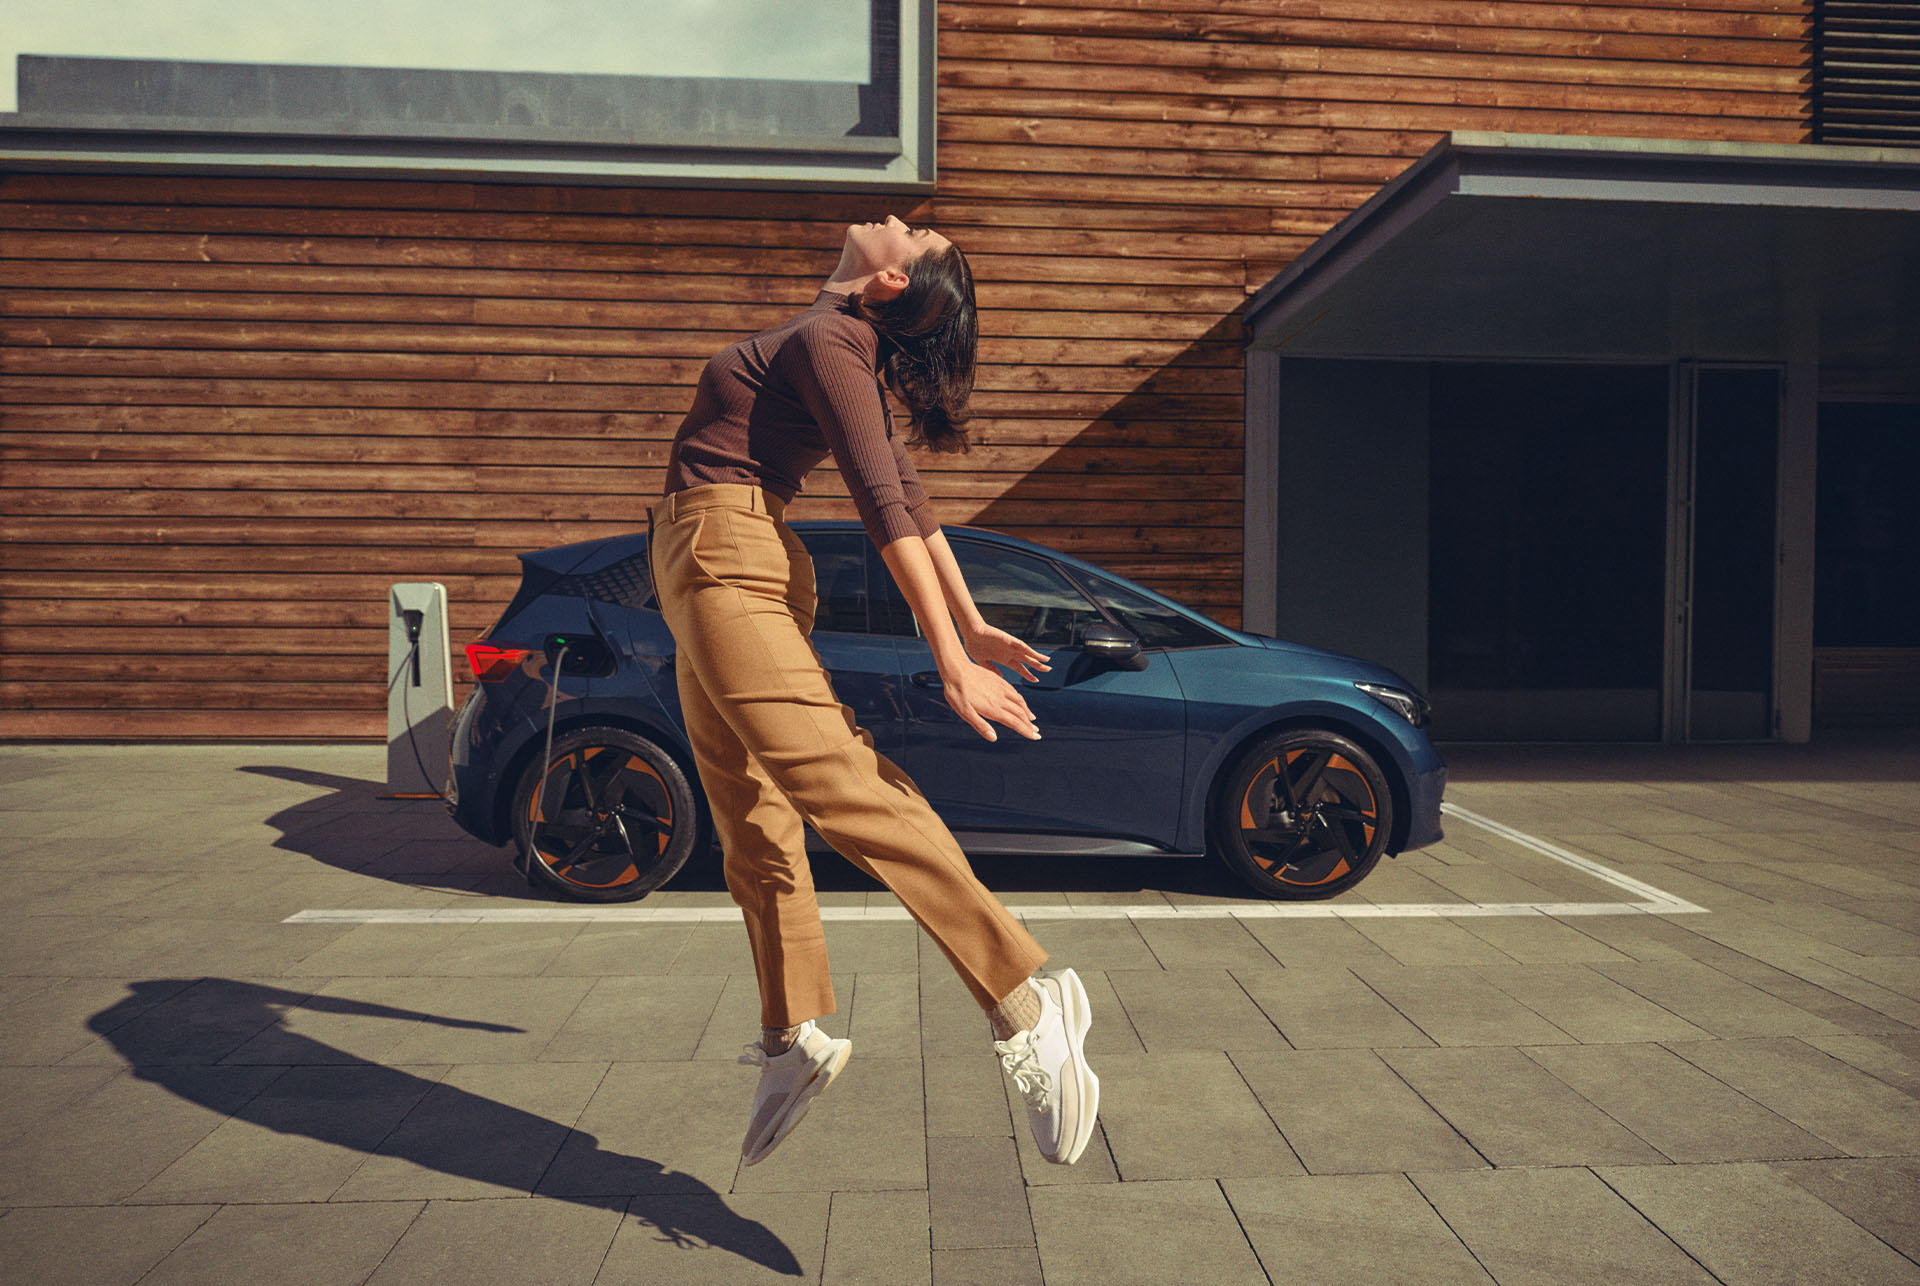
(993, 969, 1100, 1165)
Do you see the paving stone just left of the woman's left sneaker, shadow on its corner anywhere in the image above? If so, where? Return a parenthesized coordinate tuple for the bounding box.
(540, 1061, 755, 1198)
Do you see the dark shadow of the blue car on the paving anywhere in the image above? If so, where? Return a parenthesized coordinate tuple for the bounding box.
(240, 764, 1260, 906)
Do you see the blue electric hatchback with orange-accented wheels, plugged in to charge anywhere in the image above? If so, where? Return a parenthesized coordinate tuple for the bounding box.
(447, 520, 1446, 902)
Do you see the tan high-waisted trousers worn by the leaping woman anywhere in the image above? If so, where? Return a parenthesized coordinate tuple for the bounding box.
(649, 482, 1046, 1027)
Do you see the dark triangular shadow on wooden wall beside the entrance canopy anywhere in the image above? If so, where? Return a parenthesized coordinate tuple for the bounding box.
(967, 313, 1246, 628)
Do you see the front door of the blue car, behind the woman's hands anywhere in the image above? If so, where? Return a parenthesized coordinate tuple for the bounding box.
(872, 534, 1187, 843)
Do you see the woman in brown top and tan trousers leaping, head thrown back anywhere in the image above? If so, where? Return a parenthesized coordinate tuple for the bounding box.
(649, 217, 1100, 1165)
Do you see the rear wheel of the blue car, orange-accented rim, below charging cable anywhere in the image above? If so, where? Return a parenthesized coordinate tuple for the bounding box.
(513, 727, 701, 902)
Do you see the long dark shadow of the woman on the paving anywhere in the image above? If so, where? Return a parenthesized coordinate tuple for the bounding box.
(86, 977, 803, 1276)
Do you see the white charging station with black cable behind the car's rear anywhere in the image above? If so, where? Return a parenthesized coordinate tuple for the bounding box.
(386, 582, 453, 798)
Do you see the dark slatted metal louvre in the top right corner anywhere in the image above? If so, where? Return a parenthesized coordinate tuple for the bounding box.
(1812, 0, 1920, 148)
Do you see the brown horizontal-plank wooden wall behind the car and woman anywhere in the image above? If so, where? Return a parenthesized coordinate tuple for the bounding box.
(0, 0, 1807, 739)
